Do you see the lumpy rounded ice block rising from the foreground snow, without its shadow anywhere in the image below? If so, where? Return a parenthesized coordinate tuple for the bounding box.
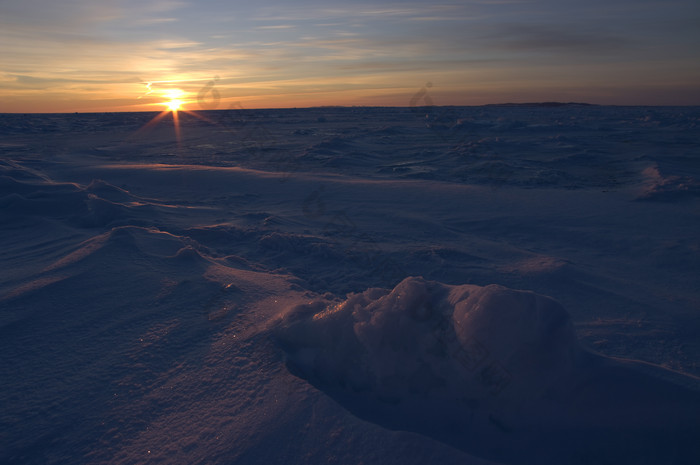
(279, 277, 577, 400)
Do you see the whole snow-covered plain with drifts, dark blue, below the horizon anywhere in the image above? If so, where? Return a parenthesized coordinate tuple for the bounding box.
(0, 105, 700, 465)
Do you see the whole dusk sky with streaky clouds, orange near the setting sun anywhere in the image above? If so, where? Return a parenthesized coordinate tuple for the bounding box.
(0, 0, 700, 113)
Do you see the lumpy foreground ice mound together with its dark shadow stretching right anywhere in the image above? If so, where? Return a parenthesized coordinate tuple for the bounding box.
(276, 277, 700, 464)
